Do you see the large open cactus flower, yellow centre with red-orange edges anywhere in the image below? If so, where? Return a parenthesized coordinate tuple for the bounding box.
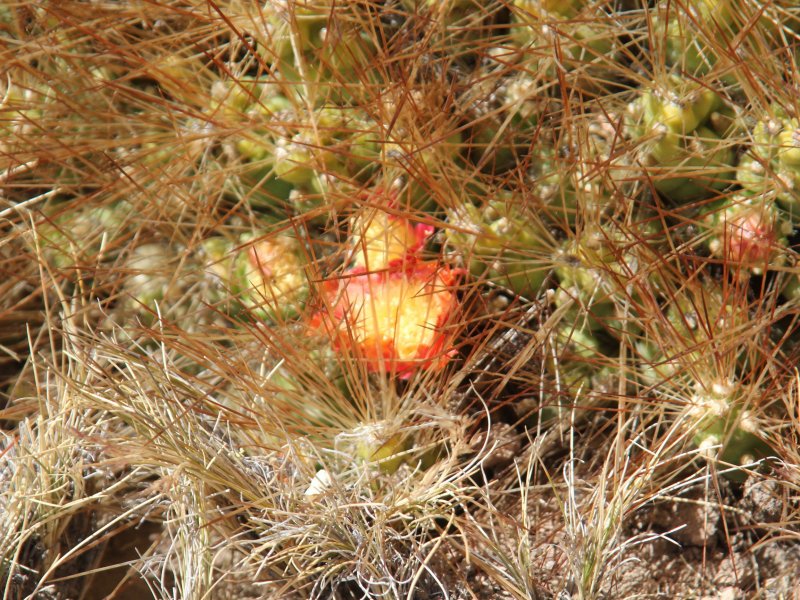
(315, 257, 459, 378)
